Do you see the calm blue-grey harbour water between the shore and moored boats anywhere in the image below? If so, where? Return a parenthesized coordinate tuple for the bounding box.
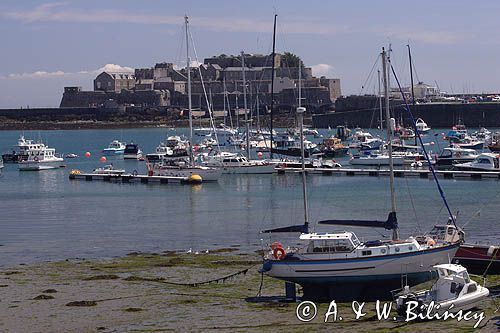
(0, 128, 500, 266)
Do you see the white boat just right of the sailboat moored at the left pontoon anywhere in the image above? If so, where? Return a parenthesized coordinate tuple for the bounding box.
(201, 152, 276, 174)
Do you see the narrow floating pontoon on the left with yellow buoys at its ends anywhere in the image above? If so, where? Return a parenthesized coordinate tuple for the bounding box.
(69, 173, 202, 185)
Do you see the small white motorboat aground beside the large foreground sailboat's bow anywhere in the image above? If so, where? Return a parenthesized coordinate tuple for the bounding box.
(396, 264, 490, 315)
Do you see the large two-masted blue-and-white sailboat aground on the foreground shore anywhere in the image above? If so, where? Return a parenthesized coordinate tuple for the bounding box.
(261, 49, 463, 301)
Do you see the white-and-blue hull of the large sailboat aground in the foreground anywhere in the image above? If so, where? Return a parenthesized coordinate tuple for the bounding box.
(264, 244, 459, 302)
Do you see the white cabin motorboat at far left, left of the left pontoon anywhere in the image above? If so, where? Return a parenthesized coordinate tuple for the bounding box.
(18, 142, 64, 171)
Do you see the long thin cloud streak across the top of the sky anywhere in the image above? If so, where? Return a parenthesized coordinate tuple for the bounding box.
(0, 2, 349, 35)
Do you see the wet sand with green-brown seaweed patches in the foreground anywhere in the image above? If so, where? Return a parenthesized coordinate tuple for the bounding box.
(0, 248, 500, 332)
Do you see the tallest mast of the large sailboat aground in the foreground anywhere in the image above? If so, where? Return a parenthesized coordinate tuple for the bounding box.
(382, 48, 399, 239)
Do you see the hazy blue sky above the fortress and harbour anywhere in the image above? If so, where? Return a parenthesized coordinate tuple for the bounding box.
(0, 0, 500, 108)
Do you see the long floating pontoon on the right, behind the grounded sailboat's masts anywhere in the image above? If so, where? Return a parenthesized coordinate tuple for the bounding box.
(275, 167, 500, 179)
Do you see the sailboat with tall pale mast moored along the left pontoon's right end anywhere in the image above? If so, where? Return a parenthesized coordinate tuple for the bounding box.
(147, 16, 222, 182)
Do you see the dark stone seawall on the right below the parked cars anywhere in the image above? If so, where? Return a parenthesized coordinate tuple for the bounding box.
(313, 103, 500, 128)
